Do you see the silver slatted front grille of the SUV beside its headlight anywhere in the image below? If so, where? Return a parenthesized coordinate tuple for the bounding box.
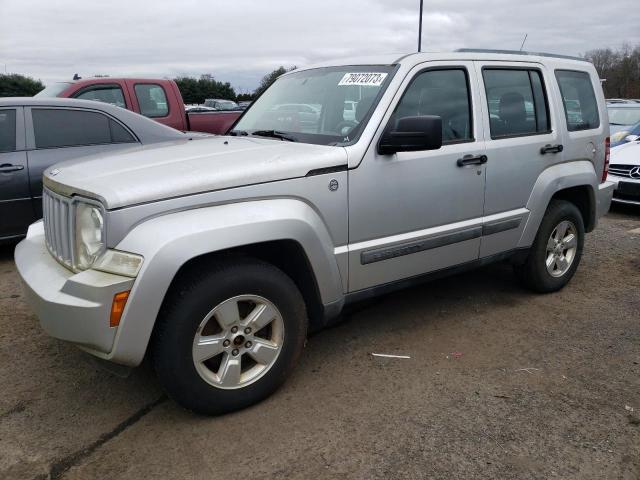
(42, 189, 73, 268)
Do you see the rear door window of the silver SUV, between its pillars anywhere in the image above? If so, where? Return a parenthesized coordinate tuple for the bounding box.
(482, 68, 551, 139)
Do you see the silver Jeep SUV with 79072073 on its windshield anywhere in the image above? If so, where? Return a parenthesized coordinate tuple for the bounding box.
(15, 51, 613, 414)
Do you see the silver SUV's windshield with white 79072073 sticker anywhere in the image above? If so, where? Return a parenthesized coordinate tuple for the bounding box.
(231, 65, 393, 145)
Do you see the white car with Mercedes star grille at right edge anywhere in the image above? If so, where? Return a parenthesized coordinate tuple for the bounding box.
(608, 138, 640, 205)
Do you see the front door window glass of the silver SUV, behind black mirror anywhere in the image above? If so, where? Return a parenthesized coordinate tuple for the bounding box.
(390, 68, 473, 144)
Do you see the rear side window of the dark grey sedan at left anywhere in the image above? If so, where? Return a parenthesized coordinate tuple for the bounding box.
(31, 108, 135, 148)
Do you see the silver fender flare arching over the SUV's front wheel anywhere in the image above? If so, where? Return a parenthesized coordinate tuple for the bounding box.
(108, 199, 344, 366)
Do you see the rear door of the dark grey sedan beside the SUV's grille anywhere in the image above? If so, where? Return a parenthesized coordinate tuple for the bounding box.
(25, 107, 138, 218)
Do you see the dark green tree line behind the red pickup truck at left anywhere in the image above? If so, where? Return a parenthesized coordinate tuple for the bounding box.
(0, 67, 295, 104)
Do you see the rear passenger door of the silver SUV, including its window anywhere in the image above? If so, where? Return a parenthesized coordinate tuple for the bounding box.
(476, 62, 563, 258)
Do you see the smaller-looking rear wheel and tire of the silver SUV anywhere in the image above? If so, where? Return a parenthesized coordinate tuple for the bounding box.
(514, 200, 585, 293)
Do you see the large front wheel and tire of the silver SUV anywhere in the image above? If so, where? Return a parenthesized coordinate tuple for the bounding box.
(153, 258, 308, 415)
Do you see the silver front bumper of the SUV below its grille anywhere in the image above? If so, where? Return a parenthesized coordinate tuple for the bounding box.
(15, 221, 134, 358)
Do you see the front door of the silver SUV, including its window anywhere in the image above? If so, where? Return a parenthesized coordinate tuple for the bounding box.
(348, 62, 490, 292)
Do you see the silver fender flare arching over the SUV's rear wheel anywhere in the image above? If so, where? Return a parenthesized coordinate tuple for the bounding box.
(518, 160, 598, 248)
